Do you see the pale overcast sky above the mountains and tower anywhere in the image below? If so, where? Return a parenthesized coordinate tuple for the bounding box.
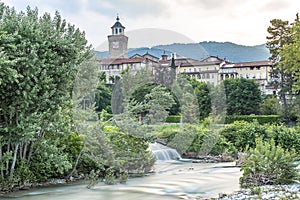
(2, 0, 300, 48)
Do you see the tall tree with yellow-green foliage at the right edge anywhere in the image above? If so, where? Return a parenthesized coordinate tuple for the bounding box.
(267, 14, 300, 123)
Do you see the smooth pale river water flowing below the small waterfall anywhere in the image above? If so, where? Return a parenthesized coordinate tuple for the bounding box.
(4, 161, 241, 200)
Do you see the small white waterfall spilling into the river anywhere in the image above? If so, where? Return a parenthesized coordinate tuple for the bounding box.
(150, 143, 181, 161)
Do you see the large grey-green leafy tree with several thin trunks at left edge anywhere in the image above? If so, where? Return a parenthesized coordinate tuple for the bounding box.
(0, 3, 92, 181)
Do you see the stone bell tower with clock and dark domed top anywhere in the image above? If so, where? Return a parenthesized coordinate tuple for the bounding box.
(108, 16, 128, 58)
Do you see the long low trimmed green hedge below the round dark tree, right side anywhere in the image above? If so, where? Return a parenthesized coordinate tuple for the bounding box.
(225, 115, 279, 124)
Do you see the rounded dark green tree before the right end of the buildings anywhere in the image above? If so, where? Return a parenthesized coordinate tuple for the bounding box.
(224, 78, 261, 115)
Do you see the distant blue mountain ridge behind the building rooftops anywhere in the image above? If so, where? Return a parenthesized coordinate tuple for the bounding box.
(95, 41, 270, 62)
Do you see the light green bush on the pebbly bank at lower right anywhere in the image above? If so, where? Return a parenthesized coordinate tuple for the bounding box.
(240, 138, 300, 187)
